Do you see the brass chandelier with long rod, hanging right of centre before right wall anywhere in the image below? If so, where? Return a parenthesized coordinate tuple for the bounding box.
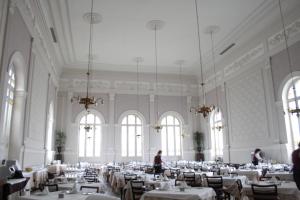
(190, 0, 214, 118)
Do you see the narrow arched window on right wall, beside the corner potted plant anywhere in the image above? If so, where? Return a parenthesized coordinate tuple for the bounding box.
(210, 109, 223, 159)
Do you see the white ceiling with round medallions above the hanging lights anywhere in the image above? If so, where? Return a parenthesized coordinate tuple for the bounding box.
(44, 0, 282, 74)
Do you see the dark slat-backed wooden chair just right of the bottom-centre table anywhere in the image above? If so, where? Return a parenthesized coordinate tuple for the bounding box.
(206, 176, 230, 200)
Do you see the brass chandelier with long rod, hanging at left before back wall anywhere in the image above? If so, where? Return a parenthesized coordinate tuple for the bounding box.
(71, 0, 103, 110)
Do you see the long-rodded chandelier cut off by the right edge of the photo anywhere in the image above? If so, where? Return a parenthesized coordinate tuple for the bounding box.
(278, 0, 300, 118)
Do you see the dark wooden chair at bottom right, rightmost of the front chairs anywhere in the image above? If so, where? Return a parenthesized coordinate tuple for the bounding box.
(251, 184, 279, 200)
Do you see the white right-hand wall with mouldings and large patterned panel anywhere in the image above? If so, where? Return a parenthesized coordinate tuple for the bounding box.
(201, 4, 300, 163)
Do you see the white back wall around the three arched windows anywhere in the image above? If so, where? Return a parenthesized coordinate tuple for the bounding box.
(57, 71, 199, 163)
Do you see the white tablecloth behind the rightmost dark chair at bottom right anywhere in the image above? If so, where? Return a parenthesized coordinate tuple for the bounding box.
(242, 182, 300, 200)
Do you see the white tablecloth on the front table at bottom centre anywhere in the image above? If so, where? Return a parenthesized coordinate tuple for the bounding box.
(141, 188, 216, 200)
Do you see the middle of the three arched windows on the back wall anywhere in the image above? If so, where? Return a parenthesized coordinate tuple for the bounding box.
(121, 114, 142, 157)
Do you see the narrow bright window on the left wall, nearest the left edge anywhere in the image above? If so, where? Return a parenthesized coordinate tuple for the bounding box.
(3, 65, 16, 140)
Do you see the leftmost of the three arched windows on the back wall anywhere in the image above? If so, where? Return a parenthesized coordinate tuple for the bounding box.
(79, 113, 101, 157)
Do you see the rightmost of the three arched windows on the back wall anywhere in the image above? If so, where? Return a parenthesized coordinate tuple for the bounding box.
(161, 115, 182, 156)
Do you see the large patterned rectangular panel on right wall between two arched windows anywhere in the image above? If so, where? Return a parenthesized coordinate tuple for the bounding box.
(228, 68, 268, 146)
